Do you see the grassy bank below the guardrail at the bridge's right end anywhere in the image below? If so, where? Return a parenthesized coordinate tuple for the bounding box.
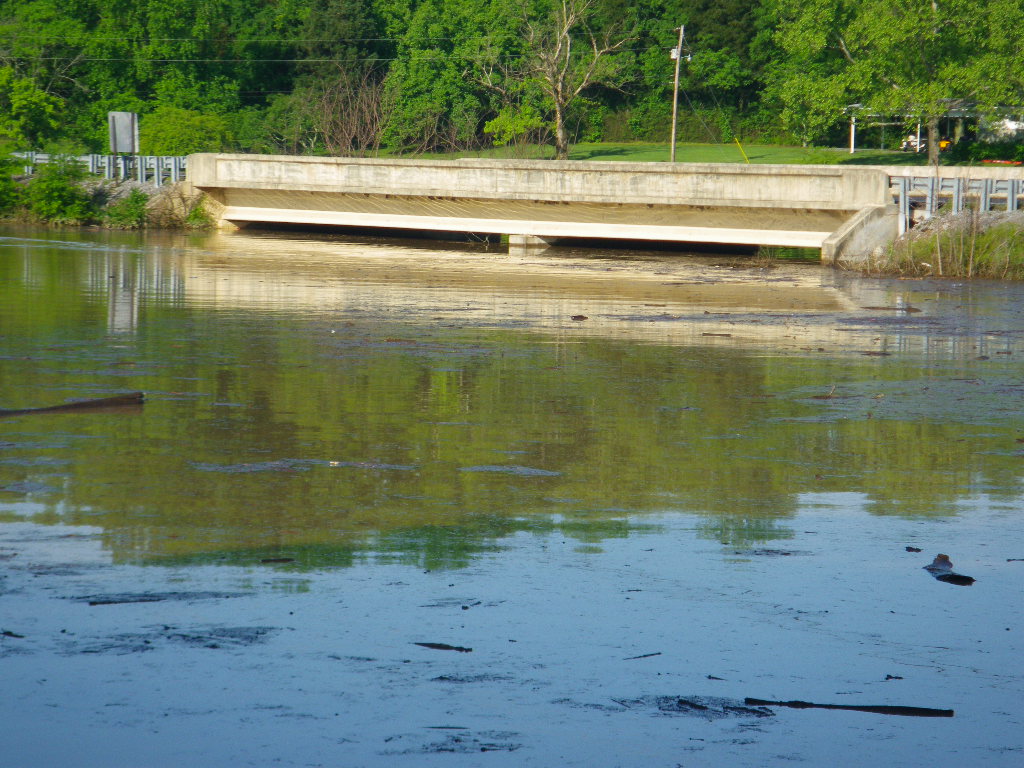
(870, 210, 1024, 280)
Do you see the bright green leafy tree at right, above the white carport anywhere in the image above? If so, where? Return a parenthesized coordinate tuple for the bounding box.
(771, 0, 1024, 163)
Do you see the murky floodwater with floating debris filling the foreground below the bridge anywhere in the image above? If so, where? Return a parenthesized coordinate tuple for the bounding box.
(0, 225, 1024, 768)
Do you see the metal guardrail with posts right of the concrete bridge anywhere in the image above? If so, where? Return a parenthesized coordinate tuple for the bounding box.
(889, 176, 1024, 234)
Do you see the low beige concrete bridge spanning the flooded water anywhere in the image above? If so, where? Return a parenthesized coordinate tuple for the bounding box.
(188, 155, 898, 263)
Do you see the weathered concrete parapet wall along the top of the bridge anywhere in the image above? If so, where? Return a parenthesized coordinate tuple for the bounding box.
(188, 155, 889, 211)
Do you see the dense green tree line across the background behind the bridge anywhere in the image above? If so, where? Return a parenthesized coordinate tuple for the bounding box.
(0, 0, 1024, 157)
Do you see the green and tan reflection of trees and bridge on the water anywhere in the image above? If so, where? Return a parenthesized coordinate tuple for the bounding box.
(0, 225, 1024, 568)
